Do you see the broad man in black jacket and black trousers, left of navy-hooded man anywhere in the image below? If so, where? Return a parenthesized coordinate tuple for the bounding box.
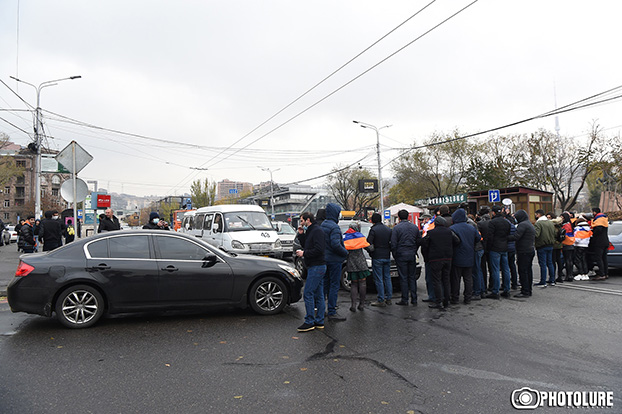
(420, 216, 460, 309)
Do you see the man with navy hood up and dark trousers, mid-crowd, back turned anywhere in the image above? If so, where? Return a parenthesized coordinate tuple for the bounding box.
(449, 208, 481, 305)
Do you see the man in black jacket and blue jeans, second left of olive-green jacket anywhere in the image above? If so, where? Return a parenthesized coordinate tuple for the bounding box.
(486, 206, 512, 299)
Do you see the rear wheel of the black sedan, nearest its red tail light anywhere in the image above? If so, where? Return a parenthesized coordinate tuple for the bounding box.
(56, 285, 104, 328)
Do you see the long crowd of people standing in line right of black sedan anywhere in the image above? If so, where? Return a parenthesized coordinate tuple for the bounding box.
(296, 203, 609, 332)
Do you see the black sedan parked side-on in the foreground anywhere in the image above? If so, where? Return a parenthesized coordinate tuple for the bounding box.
(7, 230, 303, 328)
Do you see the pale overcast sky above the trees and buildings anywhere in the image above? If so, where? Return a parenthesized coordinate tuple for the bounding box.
(0, 0, 622, 195)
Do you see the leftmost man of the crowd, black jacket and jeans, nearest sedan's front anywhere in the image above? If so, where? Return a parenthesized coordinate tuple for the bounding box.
(296, 212, 326, 332)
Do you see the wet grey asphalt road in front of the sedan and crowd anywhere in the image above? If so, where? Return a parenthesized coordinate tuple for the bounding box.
(0, 246, 622, 414)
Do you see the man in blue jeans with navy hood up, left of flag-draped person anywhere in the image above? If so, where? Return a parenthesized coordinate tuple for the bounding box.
(320, 203, 348, 320)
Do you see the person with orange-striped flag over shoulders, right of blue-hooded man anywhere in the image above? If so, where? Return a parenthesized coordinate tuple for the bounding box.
(343, 221, 371, 312)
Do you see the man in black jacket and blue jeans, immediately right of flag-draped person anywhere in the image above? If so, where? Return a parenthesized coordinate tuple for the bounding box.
(367, 213, 393, 307)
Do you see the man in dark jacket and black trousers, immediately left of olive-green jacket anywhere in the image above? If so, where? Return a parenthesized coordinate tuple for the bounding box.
(508, 210, 536, 298)
